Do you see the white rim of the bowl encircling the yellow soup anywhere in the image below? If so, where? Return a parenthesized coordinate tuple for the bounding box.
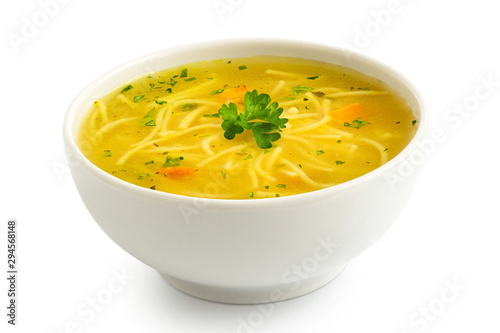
(63, 38, 429, 208)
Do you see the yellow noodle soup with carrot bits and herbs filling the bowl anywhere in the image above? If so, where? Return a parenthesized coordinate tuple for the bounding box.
(77, 56, 418, 199)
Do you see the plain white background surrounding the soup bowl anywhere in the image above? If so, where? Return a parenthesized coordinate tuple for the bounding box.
(0, 0, 500, 333)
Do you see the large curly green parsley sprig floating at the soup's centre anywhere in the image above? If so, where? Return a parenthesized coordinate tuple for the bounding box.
(219, 90, 288, 149)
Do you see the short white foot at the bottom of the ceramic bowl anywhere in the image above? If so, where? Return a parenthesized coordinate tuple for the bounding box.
(159, 265, 345, 304)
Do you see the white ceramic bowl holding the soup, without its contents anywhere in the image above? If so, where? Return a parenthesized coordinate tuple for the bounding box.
(64, 40, 427, 304)
